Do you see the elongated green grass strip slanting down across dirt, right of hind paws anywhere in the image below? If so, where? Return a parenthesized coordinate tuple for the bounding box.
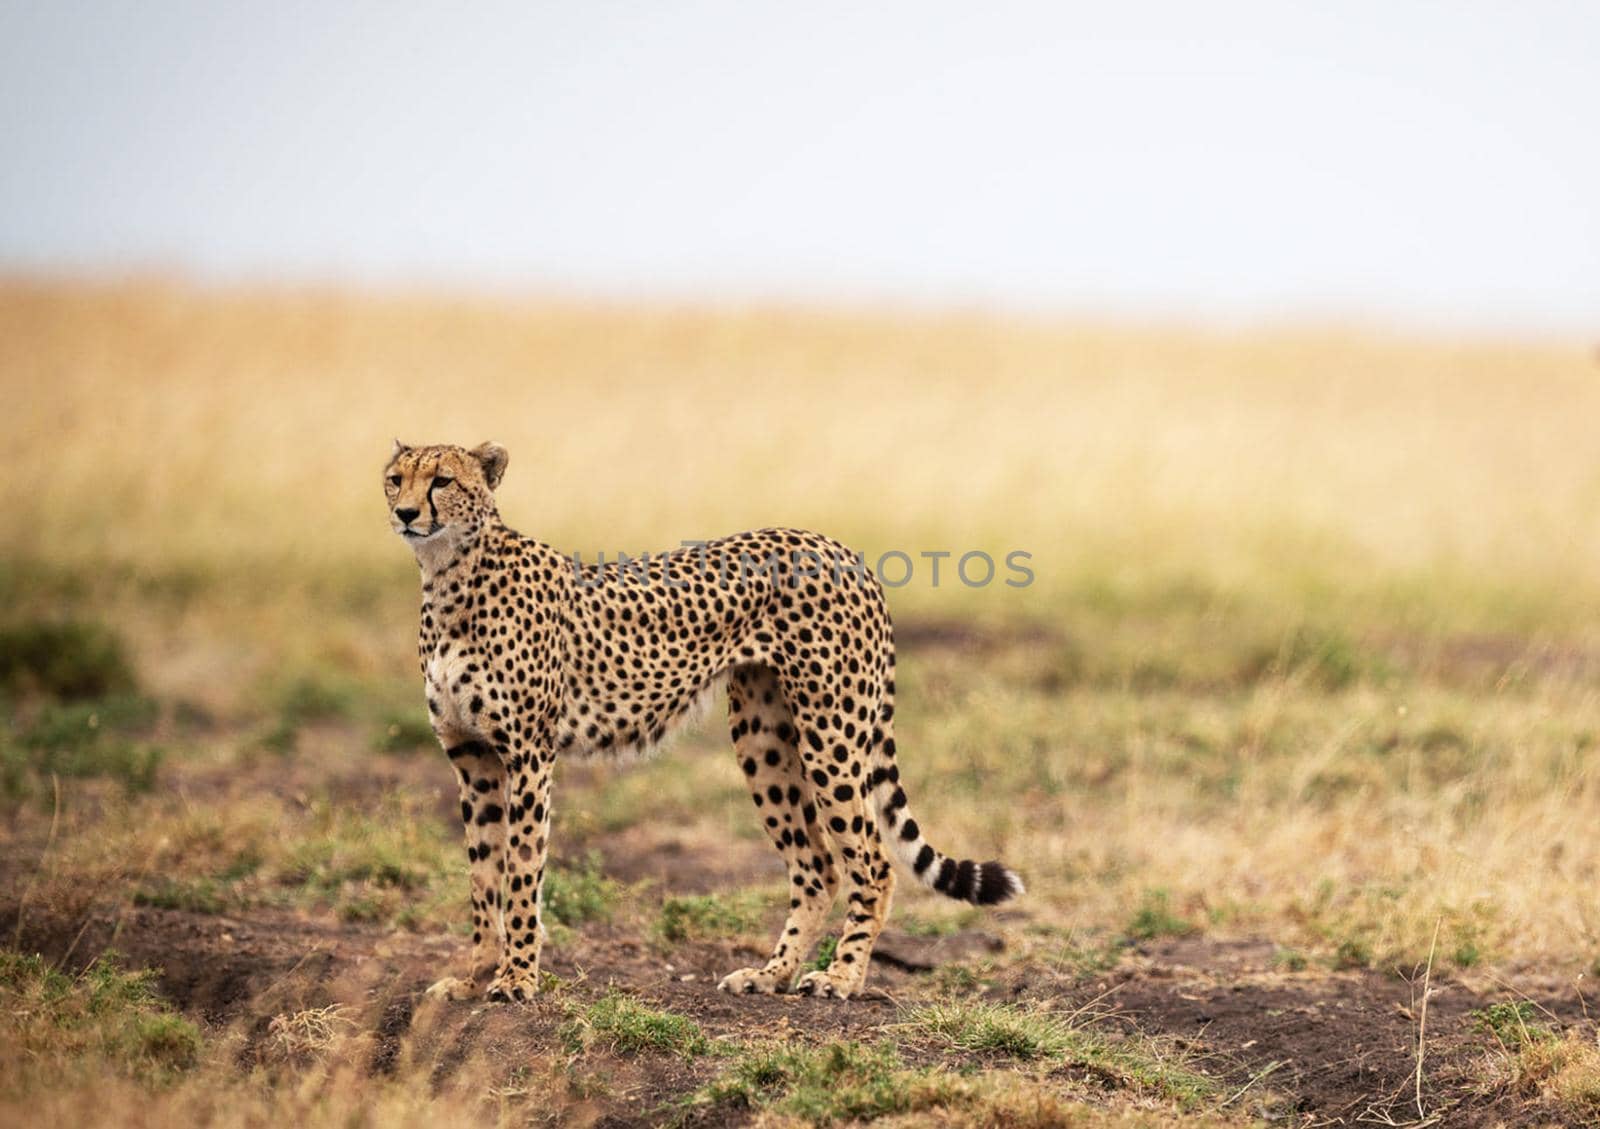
(901, 1001, 1218, 1110)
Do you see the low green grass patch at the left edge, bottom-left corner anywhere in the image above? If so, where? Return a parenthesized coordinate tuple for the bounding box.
(0, 951, 202, 1083)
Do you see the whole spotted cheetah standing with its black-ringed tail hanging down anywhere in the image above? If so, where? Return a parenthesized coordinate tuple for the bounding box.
(384, 440, 1022, 1001)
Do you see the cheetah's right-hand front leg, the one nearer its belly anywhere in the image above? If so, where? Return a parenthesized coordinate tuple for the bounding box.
(488, 750, 554, 1003)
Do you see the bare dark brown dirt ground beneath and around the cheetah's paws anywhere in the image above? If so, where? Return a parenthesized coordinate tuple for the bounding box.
(9, 742, 1590, 1127)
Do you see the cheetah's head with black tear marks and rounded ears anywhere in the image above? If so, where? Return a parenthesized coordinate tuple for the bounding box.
(384, 440, 507, 552)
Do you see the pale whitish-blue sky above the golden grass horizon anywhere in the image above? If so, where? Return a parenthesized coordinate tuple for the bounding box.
(0, 0, 1600, 333)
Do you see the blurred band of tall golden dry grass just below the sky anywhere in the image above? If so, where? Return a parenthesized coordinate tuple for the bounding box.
(0, 283, 1600, 614)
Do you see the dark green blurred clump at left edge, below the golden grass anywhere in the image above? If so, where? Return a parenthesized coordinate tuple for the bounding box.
(0, 620, 134, 699)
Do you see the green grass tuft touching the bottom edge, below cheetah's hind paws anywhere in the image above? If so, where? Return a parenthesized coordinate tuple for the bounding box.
(682, 1043, 974, 1126)
